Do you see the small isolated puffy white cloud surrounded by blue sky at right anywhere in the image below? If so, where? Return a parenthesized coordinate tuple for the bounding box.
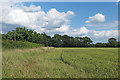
(85, 13, 105, 23)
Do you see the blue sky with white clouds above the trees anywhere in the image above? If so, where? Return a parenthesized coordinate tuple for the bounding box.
(0, 2, 118, 43)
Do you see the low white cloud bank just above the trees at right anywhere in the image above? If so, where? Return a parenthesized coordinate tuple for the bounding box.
(68, 27, 118, 42)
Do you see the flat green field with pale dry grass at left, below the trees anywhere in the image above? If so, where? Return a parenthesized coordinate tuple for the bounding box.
(2, 47, 118, 78)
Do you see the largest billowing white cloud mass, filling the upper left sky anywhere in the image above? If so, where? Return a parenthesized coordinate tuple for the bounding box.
(0, 5, 74, 33)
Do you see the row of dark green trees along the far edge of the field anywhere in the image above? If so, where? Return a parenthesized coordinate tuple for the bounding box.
(2, 27, 120, 47)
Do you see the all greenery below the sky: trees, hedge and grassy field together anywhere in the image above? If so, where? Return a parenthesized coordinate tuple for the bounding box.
(2, 27, 120, 78)
